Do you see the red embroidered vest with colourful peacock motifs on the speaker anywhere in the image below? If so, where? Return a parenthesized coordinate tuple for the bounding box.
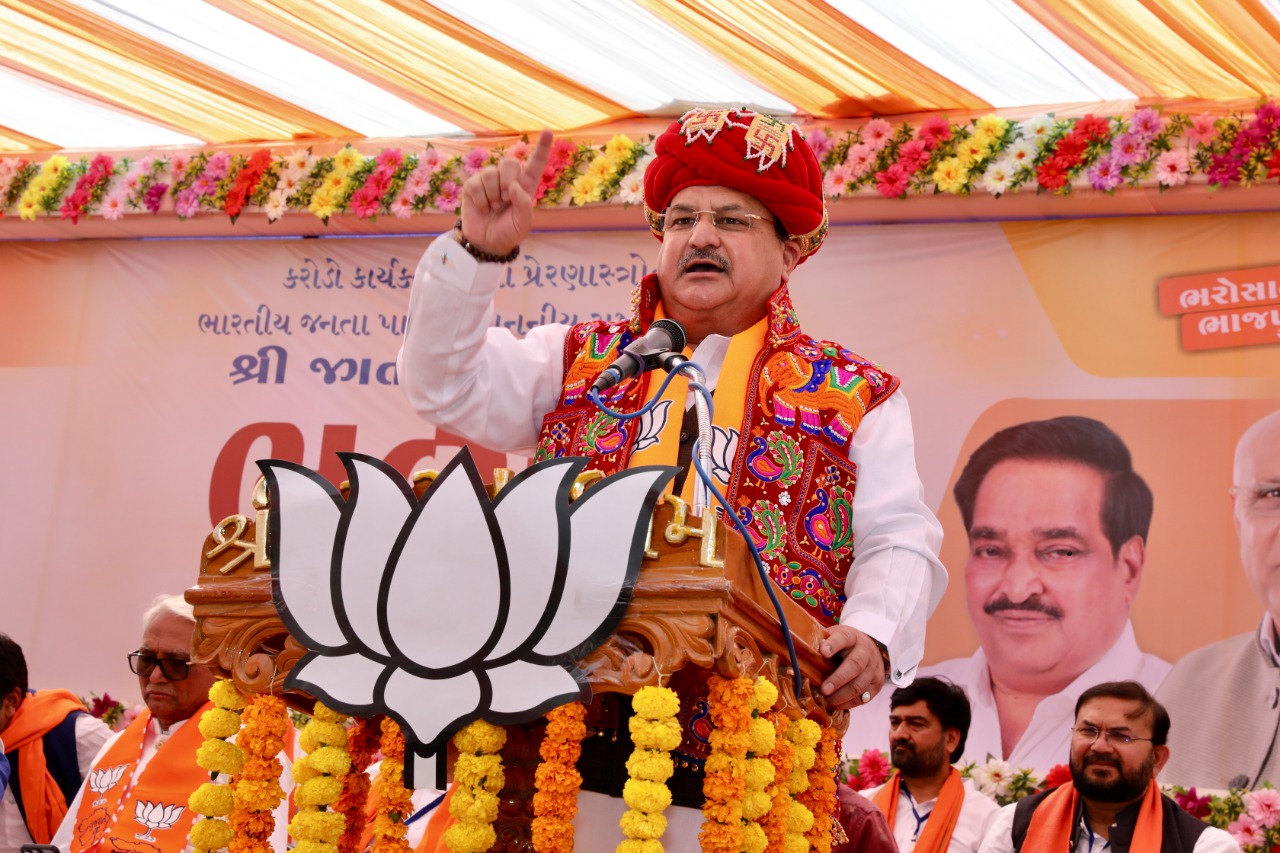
(538, 274, 899, 626)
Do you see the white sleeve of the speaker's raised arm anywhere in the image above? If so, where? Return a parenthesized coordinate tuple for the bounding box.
(397, 234, 568, 451)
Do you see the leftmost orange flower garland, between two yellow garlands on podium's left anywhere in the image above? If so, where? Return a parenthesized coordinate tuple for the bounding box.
(228, 694, 292, 853)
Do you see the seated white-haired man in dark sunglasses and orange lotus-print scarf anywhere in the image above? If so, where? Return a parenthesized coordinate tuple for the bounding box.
(54, 596, 291, 853)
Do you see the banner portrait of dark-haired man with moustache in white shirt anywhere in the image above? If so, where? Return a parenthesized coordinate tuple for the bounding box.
(845, 416, 1170, 776)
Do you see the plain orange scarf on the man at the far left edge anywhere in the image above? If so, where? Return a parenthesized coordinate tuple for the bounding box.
(0, 690, 87, 844)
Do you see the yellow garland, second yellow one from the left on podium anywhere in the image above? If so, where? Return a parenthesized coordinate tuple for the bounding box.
(289, 699, 351, 853)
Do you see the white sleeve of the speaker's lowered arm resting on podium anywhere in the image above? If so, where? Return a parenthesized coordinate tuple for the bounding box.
(840, 392, 947, 685)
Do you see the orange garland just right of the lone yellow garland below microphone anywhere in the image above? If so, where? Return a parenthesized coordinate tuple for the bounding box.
(699, 675, 755, 853)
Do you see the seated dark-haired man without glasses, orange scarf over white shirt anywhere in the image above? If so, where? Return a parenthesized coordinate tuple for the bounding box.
(863, 678, 1000, 853)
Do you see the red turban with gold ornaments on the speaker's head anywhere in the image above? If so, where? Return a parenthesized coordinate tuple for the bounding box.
(644, 109, 827, 260)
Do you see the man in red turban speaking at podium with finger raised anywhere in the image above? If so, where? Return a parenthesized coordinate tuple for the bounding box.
(398, 109, 946, 849)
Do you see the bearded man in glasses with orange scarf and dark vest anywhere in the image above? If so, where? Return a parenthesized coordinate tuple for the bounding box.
(979, 681, 1240, 853)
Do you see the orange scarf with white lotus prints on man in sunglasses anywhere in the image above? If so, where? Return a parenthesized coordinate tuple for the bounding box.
(70, 702, 212, 853)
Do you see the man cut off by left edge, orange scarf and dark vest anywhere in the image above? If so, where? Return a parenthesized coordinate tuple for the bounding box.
(0, 634, 111, 853)
